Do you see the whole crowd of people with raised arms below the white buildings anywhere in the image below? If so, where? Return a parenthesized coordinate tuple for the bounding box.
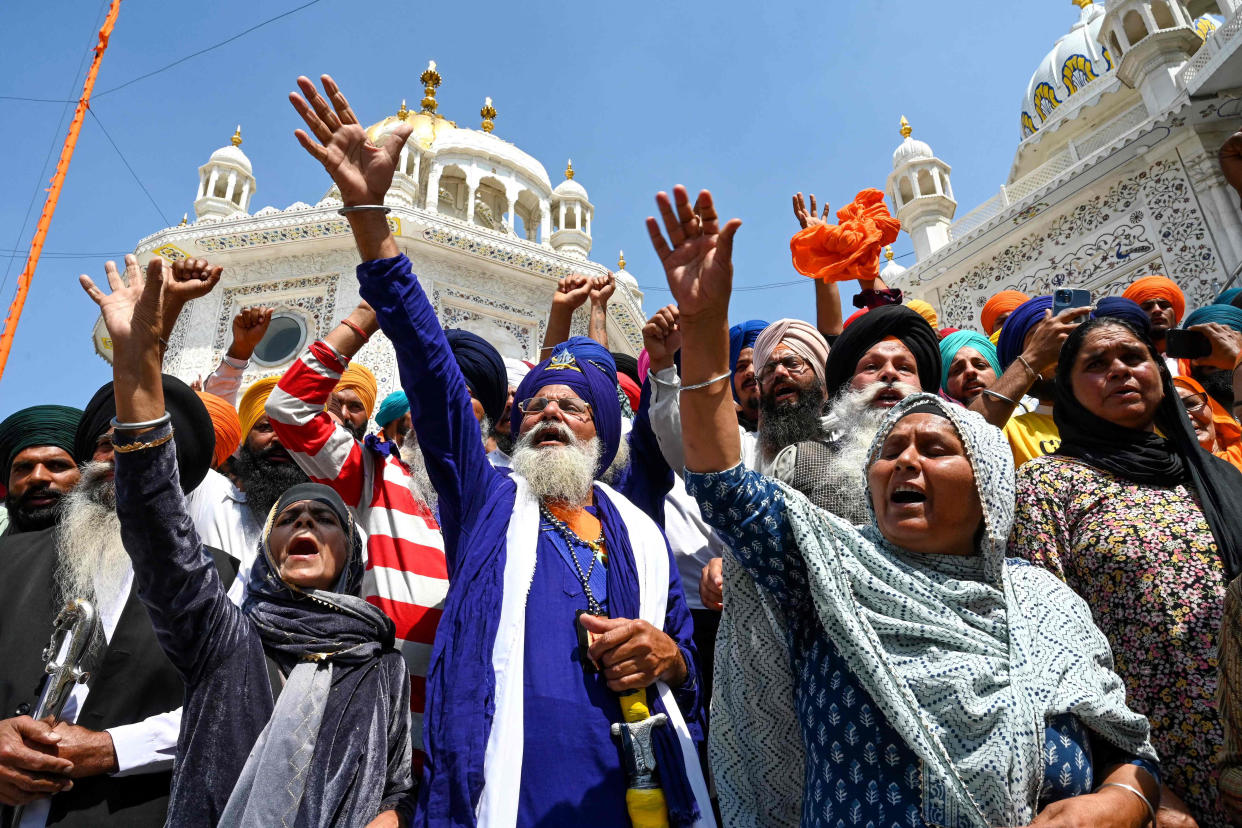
(0, 76, 1242, 828)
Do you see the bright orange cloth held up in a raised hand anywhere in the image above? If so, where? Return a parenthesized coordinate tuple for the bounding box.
(789, 189, 902, 282)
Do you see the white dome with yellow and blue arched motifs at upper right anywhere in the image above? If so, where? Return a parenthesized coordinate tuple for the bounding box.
(1021, 1, 1113, 138)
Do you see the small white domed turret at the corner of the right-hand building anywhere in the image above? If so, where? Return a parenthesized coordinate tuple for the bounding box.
(887, 115, 958, 261)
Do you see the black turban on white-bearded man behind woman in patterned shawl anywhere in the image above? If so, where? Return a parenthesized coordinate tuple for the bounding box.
(823, 304, 940, 396)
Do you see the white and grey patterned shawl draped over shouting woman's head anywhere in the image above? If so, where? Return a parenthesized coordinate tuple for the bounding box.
(713, 394, 1155, 828)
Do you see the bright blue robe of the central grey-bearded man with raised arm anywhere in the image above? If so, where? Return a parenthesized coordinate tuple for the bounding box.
(358, 256, 700, 828)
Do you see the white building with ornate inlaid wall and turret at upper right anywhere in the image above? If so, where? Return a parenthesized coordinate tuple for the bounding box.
(883, 0, 1242, 328)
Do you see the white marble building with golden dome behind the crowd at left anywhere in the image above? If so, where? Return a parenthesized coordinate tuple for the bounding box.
(94, 63, 646, 397)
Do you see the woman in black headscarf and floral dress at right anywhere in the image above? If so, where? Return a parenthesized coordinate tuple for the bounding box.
(1011, 319, 1242, 827)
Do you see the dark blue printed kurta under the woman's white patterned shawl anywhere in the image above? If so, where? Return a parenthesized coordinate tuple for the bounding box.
(686, 466, 1156, 828)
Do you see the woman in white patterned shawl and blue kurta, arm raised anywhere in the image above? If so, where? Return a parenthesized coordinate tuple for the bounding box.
(647, 187, 1158, 828)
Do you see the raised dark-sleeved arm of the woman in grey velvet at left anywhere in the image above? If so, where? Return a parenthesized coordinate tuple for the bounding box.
(81, 259, 247, 685)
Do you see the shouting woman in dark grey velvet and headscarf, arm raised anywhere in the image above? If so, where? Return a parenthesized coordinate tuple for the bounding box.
(82, 258, 414, 828)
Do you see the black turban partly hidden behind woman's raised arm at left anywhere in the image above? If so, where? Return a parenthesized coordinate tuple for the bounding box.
(73, 374, 216, 493)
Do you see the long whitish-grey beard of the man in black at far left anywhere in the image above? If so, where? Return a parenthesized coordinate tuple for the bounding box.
(56, 462, 132, 611)
